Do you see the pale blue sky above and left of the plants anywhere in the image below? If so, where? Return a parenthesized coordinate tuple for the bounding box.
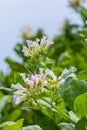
(0, 0, 74, 70)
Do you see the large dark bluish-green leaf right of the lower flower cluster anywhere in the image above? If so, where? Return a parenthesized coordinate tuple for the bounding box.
(60, 78, 87, 110)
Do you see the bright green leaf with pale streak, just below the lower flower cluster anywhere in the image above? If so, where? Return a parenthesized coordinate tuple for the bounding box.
(38, 97, 65, 123)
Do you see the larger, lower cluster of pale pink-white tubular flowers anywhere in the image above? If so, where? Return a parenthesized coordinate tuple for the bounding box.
(11, 68, 58, 104)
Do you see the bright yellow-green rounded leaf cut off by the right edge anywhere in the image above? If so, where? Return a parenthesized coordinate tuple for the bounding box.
(74, 92, 87, 118)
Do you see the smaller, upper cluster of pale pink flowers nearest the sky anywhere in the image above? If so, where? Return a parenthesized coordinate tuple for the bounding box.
(22, 36, 53, 57)
